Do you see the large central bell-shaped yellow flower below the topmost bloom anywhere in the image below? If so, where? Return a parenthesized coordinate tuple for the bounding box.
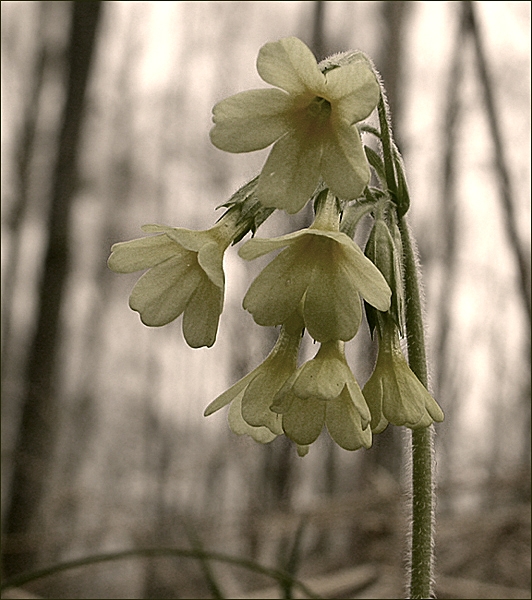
(239, 191, 391, 342)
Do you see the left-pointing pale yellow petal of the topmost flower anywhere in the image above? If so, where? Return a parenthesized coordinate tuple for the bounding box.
(210, 89, 293, 152)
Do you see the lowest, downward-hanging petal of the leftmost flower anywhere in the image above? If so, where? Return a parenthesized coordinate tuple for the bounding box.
(183, 275, 223, 348)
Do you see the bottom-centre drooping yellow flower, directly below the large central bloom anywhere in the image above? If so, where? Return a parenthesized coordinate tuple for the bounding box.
(271, 341, 371, 450)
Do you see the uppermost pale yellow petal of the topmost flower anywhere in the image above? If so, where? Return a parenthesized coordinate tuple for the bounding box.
(257, 37, 325, 96)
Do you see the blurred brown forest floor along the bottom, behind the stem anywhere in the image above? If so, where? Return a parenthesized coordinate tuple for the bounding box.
(2, 472, 531, 600)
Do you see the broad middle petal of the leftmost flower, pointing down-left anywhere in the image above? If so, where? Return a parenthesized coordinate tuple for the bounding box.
(129, 253, 205, 327)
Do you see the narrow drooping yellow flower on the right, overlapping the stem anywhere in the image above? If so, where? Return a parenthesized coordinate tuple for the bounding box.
(362, 318, 444, 433)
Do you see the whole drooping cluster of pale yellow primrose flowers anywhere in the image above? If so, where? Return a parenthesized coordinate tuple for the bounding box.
(108, 38, 443, 455)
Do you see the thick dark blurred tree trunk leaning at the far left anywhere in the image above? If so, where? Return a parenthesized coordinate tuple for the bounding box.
(3, 2, 101, 576)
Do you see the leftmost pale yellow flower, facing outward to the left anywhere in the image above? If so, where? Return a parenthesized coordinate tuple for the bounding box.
(107, 213, 243, 348)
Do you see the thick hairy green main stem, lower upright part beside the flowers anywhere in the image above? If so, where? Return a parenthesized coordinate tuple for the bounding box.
(399, 218, 434, 598)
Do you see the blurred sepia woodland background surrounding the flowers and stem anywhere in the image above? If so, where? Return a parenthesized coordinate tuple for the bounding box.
(1, 1, 530, 598)
